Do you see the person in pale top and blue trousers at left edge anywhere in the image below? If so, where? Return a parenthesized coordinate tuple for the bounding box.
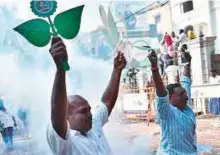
(0, 99, 17, 151)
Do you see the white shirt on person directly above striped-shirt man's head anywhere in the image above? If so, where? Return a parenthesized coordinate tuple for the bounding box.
(165, 65, 179, 84)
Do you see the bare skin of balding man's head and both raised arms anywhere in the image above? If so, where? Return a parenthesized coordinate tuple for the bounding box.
(50, 37, 126, 139)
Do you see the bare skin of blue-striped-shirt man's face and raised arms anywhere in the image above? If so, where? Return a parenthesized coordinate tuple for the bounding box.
(148, 51, 191, 110)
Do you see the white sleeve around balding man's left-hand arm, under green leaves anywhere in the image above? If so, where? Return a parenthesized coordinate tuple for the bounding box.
(47, 122, 74, 155)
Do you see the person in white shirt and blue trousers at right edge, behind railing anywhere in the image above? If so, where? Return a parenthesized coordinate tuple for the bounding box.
(209, 69, 220, 115)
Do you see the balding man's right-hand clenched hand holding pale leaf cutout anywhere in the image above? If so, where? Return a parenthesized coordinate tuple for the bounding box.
(114, 52, 127, 70)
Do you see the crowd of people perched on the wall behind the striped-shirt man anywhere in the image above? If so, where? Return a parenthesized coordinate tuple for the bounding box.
(158, 29, 192, 78)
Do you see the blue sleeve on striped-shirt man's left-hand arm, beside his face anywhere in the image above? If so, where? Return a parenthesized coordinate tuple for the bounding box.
(156, 92, 171, 121)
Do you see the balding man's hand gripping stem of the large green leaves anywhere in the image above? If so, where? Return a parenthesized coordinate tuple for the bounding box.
(50, 37, 68, 70)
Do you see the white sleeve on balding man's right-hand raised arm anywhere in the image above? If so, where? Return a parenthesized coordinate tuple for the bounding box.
(93, 103, 108, 127)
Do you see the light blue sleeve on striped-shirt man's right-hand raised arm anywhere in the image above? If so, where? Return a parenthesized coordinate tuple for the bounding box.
(180, 76, 192, 107)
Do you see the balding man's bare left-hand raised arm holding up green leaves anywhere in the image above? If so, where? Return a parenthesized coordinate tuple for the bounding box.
(50, 37, 68, 139)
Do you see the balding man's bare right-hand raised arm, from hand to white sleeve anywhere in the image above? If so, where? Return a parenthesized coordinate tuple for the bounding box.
(102, 52, 126, 115)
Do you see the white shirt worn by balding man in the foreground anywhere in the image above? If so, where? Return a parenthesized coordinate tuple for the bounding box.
(47, 104, 111, 155)
